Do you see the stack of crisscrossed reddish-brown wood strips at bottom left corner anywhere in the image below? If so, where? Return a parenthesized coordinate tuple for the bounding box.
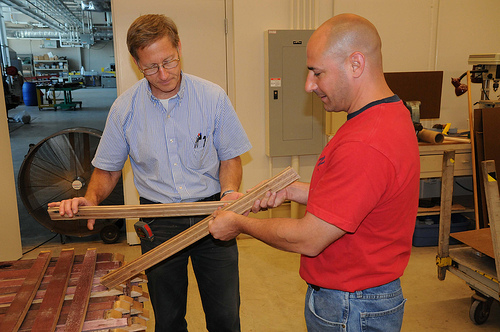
(0, 249, 149, 332)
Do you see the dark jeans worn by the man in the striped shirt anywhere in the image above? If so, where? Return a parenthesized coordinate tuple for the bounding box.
(141, 205, 240, 332)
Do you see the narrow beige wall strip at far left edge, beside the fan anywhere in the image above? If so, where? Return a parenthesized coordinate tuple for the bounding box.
(0, 84, 22, 262)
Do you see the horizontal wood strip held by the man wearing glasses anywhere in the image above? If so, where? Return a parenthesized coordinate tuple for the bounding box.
(47, 201, 232, 220)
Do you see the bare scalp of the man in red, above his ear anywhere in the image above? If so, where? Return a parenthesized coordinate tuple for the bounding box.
(311, 14, 382, 71)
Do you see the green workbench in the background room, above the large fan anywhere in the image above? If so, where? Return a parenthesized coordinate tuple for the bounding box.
(36, 83, 82, 111)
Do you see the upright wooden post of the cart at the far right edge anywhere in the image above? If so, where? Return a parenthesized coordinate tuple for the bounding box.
(481, 160, 500, 286)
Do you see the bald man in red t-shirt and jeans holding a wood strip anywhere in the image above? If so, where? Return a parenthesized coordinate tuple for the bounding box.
(209, 14, 420, 331)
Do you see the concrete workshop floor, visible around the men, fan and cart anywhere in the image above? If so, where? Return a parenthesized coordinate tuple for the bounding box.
(9, 88, 500, 332)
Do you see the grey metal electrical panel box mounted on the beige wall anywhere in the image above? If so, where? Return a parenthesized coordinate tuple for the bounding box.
(265, 30, 326, 157)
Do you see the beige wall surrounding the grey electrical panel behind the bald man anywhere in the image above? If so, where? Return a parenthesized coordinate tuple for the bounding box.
(107, 0, 500, 201)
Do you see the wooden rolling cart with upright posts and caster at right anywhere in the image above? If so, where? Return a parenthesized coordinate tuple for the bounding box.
(436, 151, 500, 325)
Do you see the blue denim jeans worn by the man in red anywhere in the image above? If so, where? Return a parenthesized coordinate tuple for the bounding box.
(304, 279, 406, 332)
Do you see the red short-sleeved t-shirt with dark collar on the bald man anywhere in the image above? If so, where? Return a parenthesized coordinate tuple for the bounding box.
(300, 96, 420, 292)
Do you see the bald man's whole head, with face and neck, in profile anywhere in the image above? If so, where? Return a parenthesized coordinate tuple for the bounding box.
(305, 14, 394, 113)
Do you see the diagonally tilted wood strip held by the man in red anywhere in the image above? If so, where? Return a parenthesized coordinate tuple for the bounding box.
(101, 167, 299, 288)
